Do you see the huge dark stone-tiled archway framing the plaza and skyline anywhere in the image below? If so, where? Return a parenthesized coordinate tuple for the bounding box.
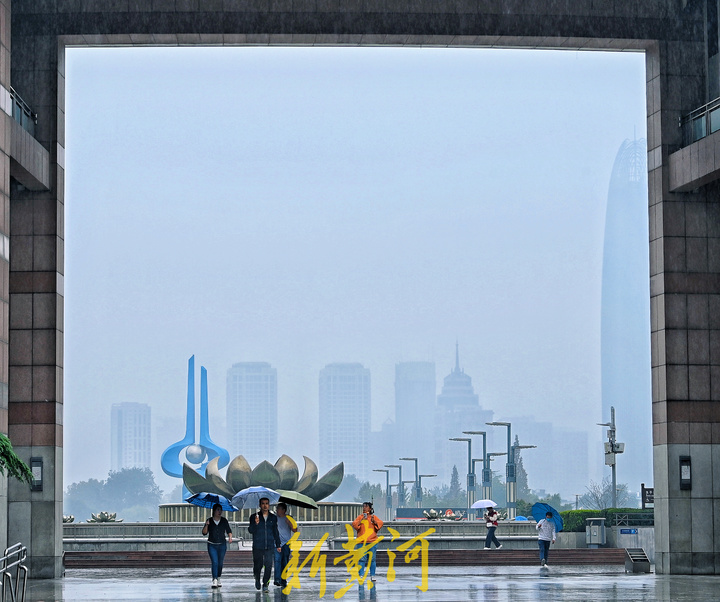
(0, 0, 720, 577)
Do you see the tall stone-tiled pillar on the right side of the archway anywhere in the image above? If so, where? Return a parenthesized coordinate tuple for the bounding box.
(647, 36, 720, 574)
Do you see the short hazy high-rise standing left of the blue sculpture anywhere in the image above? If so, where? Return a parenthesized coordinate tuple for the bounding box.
(110, 402, 151, 471)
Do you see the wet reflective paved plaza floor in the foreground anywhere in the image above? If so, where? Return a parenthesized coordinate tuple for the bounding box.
(15, 566, 720, 602)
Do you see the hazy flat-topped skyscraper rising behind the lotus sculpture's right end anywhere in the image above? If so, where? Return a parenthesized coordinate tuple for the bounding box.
(319, 364, 370, 480)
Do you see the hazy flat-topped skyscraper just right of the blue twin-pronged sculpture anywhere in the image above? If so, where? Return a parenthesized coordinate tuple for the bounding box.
(226, 362, 278, 467)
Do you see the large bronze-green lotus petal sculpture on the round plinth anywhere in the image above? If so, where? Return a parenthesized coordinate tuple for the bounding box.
(182, 454, 345, 502)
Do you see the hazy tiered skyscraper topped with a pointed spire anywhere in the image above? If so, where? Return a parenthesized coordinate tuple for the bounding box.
(433, 344, 493, 480)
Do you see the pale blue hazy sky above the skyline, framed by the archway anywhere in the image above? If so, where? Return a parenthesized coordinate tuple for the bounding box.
(65, 47, 646, 486)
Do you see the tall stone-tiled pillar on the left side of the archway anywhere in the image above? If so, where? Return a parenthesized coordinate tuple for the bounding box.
(7, 25, 65, 578)
